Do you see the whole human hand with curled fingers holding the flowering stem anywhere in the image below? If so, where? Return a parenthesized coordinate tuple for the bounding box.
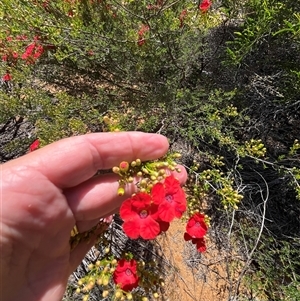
(0, 132, 186, 301)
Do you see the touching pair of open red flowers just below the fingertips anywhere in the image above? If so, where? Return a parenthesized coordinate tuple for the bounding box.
(120, 176, 186, 239)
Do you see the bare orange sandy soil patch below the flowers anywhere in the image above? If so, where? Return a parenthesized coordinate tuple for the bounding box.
(160, 221, 227, 301)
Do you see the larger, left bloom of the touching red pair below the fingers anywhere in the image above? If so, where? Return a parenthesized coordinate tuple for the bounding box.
(120, 192, 161, 239)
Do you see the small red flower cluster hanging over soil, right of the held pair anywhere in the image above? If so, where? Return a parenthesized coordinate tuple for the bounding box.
(184, 213, 207, 252)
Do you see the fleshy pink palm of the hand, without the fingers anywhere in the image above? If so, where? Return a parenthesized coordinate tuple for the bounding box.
(1, 169, 77, 300)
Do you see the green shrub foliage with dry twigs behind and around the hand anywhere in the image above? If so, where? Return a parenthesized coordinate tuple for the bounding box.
(0, 0, 300, 300)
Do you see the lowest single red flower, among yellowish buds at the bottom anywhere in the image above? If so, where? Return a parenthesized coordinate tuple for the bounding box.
(113, 259, 139, 292)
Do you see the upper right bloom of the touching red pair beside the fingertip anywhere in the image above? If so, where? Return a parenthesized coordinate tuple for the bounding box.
(151, 176, 186, 222)
